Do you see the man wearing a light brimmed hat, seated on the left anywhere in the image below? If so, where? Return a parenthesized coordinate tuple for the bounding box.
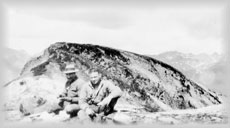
(58, 64, 83, 117)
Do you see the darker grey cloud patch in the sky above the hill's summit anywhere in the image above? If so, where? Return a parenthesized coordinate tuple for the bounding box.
(46, 11, 132, 29)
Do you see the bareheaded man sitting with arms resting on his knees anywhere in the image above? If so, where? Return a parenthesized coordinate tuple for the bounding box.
(78, 69, 122, 119)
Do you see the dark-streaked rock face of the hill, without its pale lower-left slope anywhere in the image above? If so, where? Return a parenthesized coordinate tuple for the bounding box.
(17, 42, 221, 112)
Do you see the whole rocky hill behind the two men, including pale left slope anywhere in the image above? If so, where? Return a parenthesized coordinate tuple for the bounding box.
(4, 42, 222, 121)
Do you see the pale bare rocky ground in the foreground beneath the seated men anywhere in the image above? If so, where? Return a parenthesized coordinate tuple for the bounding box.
(2, 96, 228, 125)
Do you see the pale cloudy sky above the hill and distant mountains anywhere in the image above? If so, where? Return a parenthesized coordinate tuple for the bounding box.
(2, 2, 224, 55)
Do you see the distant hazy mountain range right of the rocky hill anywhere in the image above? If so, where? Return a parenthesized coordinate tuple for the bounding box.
(151, 51, 227, 94)
